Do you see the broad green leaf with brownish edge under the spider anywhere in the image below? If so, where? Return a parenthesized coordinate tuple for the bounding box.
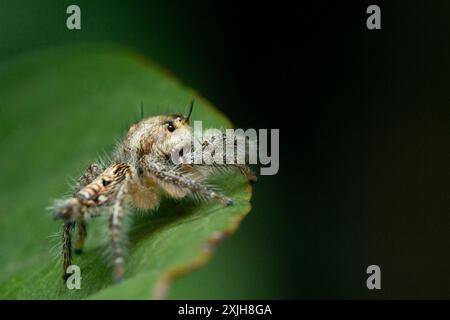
(0, 45, 251, 299)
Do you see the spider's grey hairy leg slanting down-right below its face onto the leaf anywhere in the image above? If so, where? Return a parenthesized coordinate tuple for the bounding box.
(139, 155, 233, 206)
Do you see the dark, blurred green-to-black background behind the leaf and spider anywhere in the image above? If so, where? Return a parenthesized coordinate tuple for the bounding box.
(0, 0, 450, 299)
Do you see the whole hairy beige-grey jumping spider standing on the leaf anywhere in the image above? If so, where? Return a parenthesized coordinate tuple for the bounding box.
(52, 104, 255, 280)
